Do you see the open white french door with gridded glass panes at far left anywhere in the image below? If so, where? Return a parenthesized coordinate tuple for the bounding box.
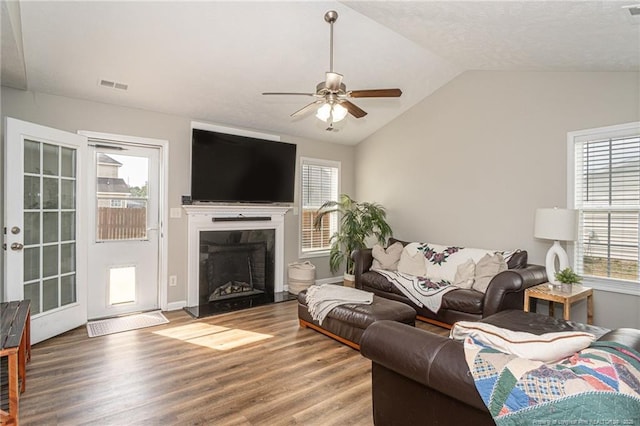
(4, 118, 87, 343)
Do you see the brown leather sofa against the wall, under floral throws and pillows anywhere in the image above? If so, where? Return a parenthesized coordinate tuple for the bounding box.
(351, 238, 547, 327)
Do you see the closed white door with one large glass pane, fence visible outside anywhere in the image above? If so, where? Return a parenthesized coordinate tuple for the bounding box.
(85, 133, 162, 319)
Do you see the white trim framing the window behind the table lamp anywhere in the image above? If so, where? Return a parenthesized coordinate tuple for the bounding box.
(567, 121, 640, 296)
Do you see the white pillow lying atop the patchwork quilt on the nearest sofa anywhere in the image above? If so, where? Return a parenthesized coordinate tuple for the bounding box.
(451, 321, 596, 362)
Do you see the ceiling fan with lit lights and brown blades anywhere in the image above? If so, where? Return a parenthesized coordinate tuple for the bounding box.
(263, 10, 402, 131)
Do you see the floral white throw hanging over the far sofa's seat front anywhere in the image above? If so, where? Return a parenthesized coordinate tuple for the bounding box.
(374, 269, 458, 314)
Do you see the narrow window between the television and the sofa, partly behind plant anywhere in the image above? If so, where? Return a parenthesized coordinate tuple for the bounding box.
(300, 158, 340, 256)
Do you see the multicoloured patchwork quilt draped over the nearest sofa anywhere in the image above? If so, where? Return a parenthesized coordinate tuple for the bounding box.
(464, 337, 640, 426)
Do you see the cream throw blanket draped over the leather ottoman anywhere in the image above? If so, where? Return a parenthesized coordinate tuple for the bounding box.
(306, 284, 373, 325)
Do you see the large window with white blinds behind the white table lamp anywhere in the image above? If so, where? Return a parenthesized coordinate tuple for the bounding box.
(568, 123, 640, 294)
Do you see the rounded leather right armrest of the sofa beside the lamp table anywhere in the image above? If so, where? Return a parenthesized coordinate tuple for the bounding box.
(482, 265, 547, 318)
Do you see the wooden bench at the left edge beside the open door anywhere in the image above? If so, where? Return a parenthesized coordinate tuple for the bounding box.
(0, 300, 31, 425)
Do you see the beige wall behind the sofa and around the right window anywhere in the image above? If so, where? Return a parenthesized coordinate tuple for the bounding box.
(355, 71, 640, 327)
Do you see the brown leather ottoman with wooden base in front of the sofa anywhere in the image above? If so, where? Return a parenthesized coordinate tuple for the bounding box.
(298, 290, 416, 350)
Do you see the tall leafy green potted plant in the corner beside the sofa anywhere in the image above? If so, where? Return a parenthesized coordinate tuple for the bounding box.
(313, 194, 393, 286)
